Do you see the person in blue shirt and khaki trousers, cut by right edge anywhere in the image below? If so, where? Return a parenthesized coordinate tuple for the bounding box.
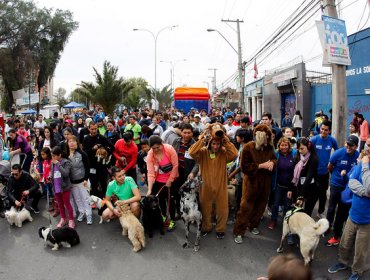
(328, 147, 370, 280)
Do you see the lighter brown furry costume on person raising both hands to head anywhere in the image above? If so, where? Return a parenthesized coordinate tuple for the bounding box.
(189, 126, 238, 232)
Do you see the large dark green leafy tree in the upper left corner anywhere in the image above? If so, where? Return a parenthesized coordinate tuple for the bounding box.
(0, 0, 78, 111)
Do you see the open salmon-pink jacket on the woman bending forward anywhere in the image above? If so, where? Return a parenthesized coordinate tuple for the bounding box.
(146, 144, 179, 183)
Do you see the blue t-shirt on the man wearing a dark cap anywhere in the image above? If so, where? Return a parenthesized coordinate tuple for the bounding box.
(329, 147, 359, 188)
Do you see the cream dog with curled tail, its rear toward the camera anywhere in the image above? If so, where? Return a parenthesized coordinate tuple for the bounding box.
(277, 212, 329, 265)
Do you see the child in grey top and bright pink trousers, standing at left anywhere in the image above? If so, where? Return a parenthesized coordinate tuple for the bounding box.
(51, 146, 75, 228)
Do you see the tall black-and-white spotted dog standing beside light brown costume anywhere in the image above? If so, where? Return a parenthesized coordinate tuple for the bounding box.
(180, 175, 202, 251)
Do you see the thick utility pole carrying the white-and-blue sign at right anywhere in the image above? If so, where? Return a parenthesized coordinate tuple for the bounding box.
(323, 0, 347, 146)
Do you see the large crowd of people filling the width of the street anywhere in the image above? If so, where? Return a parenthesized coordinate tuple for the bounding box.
(0, 108, 370, 279)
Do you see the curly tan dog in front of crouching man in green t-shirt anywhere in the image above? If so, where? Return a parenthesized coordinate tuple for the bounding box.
(115, 200, 145, 252)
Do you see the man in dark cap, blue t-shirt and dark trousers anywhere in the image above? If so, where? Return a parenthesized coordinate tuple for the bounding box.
(326, 135, 360, 246)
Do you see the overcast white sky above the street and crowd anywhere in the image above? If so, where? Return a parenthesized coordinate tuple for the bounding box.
(37, 0, 370, 92)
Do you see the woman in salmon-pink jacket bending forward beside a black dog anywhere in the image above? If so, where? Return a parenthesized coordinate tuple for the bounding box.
(146, 135, 179, 231)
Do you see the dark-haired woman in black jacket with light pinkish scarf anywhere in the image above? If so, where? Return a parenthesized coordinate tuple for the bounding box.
(288, 138, 319, 216)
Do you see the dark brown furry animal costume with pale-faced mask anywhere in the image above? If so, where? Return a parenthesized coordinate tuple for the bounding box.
(234, 124, 276, 236)
